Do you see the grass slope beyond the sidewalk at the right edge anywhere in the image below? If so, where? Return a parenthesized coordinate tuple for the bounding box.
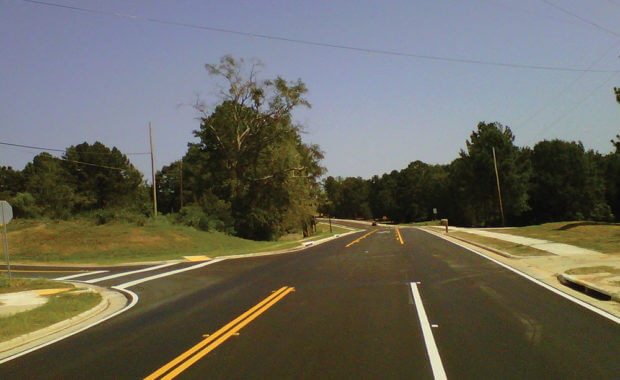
(493, 222, 620, 255)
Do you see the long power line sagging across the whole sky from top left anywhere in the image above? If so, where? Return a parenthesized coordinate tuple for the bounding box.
(22, 0, 620, 73)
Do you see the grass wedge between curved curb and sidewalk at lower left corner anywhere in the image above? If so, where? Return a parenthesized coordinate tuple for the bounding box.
(0, 283, 101, 341)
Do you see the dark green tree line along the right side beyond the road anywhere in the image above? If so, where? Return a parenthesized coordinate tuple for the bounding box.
(320, 122, 620, 226)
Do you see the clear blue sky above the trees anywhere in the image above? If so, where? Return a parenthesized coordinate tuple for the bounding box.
(0, 0, 620, 178)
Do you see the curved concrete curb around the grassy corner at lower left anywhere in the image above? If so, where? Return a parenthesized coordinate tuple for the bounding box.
(0, 281, 127, 360)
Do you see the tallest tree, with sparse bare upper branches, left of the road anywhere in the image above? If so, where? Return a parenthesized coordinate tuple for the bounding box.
(183, 56, 324, 240)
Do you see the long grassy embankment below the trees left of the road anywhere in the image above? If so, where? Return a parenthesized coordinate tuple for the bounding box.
(2, 219, 348, 264)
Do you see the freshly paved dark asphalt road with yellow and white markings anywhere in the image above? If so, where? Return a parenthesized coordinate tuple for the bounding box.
(0, 227, 620, 379)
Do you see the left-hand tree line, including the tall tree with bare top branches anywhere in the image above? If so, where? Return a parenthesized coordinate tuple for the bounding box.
(0, 56, 324, 240)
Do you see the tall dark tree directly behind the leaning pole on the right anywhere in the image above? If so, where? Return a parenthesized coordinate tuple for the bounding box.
(451, 122, 531, 226)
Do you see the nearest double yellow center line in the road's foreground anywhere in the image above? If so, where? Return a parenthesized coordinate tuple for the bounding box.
(145, 286, 295, 380)
